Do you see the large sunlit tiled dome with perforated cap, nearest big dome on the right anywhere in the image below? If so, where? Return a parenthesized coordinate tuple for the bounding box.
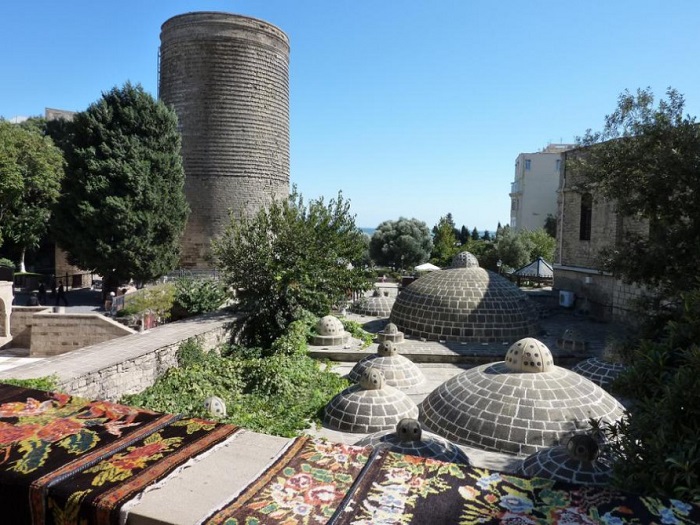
(421, 338, 623, 455)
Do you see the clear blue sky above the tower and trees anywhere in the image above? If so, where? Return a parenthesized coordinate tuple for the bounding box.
(0, 0, 700, 230)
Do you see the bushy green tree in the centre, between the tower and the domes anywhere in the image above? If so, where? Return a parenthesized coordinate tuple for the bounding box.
(213, 190, 372, 348)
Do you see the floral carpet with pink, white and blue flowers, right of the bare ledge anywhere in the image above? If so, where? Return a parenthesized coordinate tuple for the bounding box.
(201, 438, 700, 525)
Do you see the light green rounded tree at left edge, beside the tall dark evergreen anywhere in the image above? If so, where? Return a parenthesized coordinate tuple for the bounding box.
(0, 120, 63, 272)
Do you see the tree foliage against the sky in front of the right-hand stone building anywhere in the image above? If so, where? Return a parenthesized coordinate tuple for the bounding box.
(567, 88, 700, 295)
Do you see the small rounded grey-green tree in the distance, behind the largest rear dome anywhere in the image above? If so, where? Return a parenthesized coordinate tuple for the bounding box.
(369, 217, 433, 270)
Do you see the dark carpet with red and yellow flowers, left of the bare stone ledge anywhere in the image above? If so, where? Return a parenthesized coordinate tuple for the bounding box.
(0, 384, 238, 525)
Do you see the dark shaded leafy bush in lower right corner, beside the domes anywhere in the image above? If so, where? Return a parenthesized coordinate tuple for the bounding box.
(606, 290, 700, 503)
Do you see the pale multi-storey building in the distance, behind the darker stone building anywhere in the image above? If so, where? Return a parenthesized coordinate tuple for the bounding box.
(510, 144, 574, 230)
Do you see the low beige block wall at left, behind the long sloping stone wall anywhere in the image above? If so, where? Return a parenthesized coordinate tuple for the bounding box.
(29, 313, 136, 357)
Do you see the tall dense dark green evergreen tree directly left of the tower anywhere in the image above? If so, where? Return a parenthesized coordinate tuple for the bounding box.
(54, 83, 188, 292)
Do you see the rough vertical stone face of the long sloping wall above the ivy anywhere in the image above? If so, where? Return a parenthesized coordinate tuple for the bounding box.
(59, 318, 230, 401)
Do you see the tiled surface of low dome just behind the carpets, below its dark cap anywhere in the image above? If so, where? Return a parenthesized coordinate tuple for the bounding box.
(355, 430, 470, 465)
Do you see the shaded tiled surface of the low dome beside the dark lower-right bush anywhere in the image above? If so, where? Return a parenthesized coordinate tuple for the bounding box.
(520, 445, 612, 485)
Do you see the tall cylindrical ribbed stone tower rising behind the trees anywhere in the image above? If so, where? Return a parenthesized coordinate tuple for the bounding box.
(159, 12, 289, 268)
